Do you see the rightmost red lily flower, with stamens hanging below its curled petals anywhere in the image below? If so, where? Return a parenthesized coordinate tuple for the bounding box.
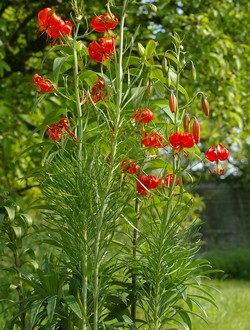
(205, 143, 229, 175)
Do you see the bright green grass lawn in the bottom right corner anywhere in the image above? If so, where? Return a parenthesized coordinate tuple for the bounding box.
(193, 280, 250, 330)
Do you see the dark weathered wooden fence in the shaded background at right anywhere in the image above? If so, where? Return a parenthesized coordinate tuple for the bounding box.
(198, 181, 250, 248)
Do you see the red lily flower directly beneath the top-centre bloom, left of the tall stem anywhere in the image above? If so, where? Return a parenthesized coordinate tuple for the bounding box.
(88, 38, 115, 62)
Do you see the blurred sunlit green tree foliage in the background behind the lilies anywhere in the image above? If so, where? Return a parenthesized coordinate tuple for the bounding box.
(0, 0, 250, 202)
